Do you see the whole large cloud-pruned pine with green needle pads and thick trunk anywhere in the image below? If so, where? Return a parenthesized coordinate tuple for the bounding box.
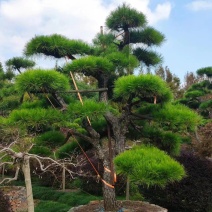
(0, 4, 202, 212)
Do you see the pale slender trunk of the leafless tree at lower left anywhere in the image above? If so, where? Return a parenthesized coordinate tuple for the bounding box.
(22, 155, 34, 212)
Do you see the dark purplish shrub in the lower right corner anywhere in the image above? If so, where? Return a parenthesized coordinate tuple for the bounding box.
(139, 152, 212, 212)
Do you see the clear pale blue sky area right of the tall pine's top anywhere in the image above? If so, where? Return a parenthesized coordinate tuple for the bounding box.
(154, 0, 212, 78)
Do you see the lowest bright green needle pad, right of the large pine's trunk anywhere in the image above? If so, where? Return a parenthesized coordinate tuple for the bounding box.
(114, 145, 185, 186)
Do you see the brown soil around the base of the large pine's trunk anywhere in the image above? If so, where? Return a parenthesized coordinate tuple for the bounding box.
(70, 201, 167, 212)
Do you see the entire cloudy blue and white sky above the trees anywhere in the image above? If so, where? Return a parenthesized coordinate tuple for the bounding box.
(0, 0, 212, 80)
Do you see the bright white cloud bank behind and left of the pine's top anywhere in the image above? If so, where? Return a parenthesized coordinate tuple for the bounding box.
(0, 0, 171, 67)
